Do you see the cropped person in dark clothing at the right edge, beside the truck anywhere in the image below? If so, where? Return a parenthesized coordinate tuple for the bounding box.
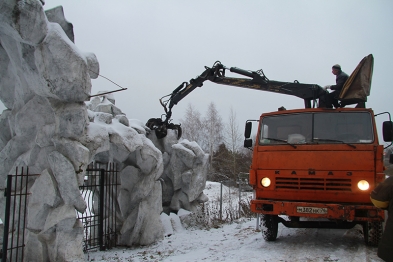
(371, 176, 393, 262)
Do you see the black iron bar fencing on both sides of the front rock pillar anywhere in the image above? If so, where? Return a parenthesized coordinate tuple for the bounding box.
(0, 163, 119, 262)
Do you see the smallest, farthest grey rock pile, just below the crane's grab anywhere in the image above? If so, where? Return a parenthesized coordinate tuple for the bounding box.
(148, 132, 209, 214)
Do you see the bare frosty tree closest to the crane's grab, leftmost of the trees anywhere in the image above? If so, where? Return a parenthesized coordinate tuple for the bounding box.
(180, 103, 203, 144)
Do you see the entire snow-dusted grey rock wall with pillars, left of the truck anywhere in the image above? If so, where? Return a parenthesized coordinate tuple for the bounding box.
(0, 0, 208, 261)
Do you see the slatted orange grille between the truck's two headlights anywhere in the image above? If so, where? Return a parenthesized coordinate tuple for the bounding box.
(276, 177, 352, 192)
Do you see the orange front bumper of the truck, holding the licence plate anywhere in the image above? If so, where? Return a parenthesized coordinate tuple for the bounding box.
(251, 199, 385, 221)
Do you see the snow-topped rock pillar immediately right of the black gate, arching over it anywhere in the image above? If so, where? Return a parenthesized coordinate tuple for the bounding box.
(82, 95, 163, 246)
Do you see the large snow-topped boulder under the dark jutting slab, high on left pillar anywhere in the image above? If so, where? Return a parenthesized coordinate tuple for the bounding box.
(34, 23, 91, 102)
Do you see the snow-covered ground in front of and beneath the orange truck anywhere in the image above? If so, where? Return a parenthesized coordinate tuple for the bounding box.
(86, 182, 382, 262)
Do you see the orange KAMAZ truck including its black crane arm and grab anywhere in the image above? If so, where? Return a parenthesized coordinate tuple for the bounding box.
(146, 54, 393, 245)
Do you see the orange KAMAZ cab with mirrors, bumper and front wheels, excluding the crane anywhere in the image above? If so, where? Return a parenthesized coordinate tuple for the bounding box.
(245, 108, 392, 245)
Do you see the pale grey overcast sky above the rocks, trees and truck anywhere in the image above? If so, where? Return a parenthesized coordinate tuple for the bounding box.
(3, 0, 393, 145)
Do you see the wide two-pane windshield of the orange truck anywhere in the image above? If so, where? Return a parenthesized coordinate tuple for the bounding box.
(259, 112, 374, 145)
